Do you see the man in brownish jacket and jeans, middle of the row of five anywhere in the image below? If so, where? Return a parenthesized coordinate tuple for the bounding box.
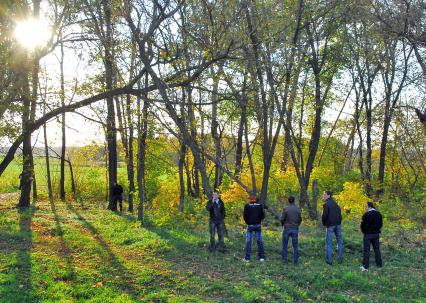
(281, 196, 302, 265)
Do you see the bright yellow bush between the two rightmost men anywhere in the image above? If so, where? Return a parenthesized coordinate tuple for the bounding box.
(334, 182, 369, 219)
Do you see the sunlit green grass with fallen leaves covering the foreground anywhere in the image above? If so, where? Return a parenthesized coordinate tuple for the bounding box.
(0, 195, 426, 303)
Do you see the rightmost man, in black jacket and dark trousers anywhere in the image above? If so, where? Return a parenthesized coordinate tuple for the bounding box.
(361, 202, 383, 271)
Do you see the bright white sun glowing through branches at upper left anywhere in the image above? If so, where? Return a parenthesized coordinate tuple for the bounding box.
(15, 19, 51, 49)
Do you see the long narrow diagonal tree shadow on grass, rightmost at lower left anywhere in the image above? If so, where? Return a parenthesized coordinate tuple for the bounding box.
(65, 201, 140, 301)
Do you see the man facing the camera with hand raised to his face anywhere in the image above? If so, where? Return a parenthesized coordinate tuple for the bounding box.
(206, 190, 225, 252)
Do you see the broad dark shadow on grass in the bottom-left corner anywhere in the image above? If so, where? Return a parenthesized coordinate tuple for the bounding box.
(0, 204, 37, 303)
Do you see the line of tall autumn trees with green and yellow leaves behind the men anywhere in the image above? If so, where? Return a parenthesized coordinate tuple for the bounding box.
(0, 0, 426, 220)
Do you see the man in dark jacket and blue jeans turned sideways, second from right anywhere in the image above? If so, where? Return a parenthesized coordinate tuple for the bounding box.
(322, 191, 343, 265)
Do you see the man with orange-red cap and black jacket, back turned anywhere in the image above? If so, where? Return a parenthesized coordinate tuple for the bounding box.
(244, 196, 265, 262)
